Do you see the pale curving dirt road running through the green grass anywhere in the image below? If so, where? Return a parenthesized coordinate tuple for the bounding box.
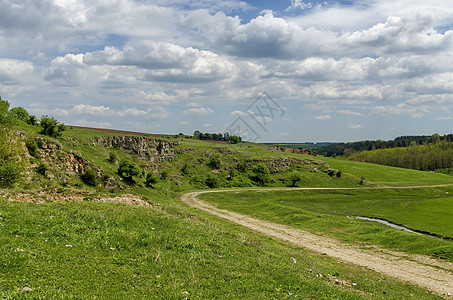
(181, 187, 453, 299)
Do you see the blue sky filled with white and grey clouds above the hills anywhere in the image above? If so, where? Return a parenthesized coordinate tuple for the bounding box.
(0, 0, 453, 142)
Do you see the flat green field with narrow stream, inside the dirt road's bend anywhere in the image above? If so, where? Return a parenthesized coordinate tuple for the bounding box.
(200, 187, 453, 261)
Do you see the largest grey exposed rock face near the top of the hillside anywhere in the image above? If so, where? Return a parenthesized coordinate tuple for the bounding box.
(90, 136, 179, 162)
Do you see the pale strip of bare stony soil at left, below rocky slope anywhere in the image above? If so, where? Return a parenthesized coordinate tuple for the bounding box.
(0, 189, 152, 206)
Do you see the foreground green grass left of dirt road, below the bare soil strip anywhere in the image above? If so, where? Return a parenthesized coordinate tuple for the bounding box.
(0, 199, 436, 299)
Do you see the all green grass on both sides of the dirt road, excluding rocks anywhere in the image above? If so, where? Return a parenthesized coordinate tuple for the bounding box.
(0, 123, 453, 299)
